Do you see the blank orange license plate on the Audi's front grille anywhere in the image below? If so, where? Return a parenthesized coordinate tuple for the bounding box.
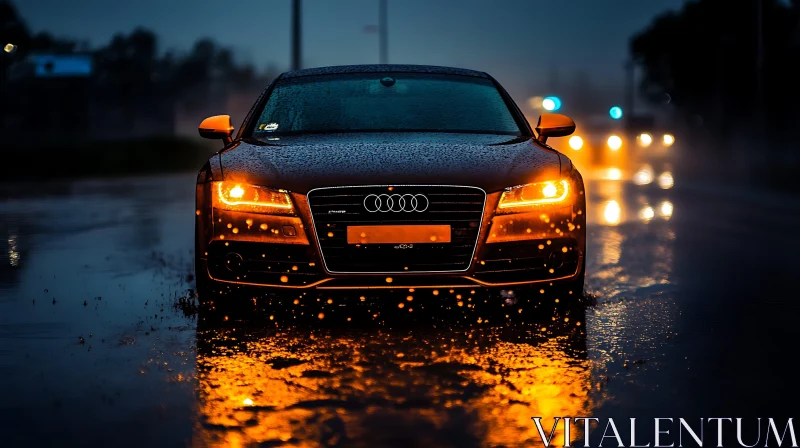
(347, 225, 450, 244)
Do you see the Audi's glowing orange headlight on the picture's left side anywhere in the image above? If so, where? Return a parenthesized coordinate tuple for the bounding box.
(212, 182, 294, 215)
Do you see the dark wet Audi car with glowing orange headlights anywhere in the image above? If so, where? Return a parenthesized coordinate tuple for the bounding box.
(195, 65, 586, 302)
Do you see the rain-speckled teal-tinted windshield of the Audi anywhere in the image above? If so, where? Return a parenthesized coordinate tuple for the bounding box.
(252, 73, 521, 138)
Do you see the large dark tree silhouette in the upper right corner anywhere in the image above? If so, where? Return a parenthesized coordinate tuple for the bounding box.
(630, 0, 800, 150)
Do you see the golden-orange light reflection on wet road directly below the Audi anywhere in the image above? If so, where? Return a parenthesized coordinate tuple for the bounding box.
(195, 316, 597, 446)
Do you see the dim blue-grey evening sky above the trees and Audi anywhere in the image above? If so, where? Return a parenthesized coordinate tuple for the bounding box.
(16, 0, 684, 102)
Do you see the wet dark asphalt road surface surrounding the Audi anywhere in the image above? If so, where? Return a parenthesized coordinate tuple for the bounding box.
(0, 174, 800, 447)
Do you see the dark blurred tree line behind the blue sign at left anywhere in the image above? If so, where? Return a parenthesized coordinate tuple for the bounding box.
(0, 0, 277, 136)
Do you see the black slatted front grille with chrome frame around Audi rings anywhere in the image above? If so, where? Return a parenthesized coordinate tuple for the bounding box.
(308, 185, 486, 273)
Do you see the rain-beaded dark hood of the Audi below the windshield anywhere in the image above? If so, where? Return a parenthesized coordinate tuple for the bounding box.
(219, 133, 560, 193)
